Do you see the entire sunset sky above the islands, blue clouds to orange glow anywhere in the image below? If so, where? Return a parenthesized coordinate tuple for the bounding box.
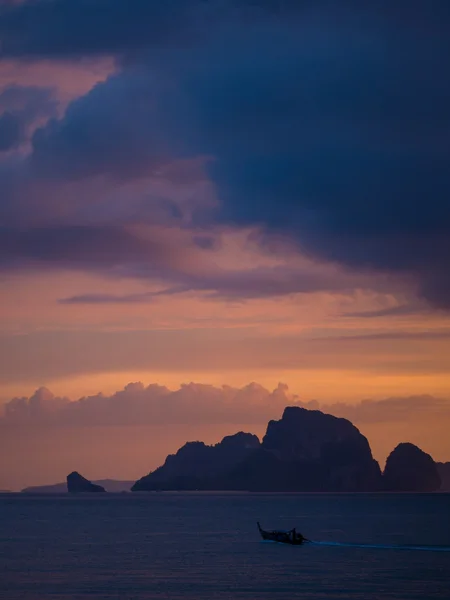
(0, 0, 450, 489)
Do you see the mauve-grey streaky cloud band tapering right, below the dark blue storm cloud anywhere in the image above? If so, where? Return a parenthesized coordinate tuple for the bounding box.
(0, 223, 403, 304)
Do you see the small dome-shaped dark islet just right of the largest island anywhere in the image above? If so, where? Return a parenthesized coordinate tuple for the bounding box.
(383, 443, 441, 492)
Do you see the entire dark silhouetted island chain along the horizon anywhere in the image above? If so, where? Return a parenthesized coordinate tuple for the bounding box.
(22, 406, 450, 493)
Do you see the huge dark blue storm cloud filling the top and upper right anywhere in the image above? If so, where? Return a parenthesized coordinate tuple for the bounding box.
(0, 0, 450, 309)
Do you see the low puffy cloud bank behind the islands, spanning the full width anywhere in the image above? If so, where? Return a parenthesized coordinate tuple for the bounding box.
(0, 382, 450, 427)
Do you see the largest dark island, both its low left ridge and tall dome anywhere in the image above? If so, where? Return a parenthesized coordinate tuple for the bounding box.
(132, 407, 382, 492)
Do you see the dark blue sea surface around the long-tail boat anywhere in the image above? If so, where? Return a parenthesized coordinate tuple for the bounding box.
(0, 493, 450, 600)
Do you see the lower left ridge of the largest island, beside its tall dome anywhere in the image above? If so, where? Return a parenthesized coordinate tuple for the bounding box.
(131, 432, 260, 492)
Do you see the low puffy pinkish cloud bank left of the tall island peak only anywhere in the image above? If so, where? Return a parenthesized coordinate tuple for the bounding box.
(3, 383, 291, 426)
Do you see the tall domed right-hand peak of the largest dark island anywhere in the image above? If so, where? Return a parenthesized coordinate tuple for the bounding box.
(230, 406, 381, 492)
